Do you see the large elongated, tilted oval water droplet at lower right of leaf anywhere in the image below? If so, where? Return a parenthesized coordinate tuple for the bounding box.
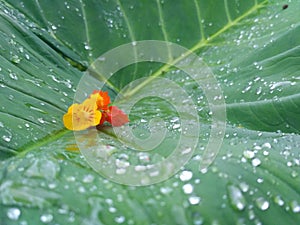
(227, 185, 246, 211)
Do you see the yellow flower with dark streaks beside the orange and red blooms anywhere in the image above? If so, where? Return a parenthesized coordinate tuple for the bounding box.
(63, 96, 102, 130)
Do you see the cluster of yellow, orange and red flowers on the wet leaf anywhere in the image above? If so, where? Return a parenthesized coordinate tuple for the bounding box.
(63, 91, 129, 130)
